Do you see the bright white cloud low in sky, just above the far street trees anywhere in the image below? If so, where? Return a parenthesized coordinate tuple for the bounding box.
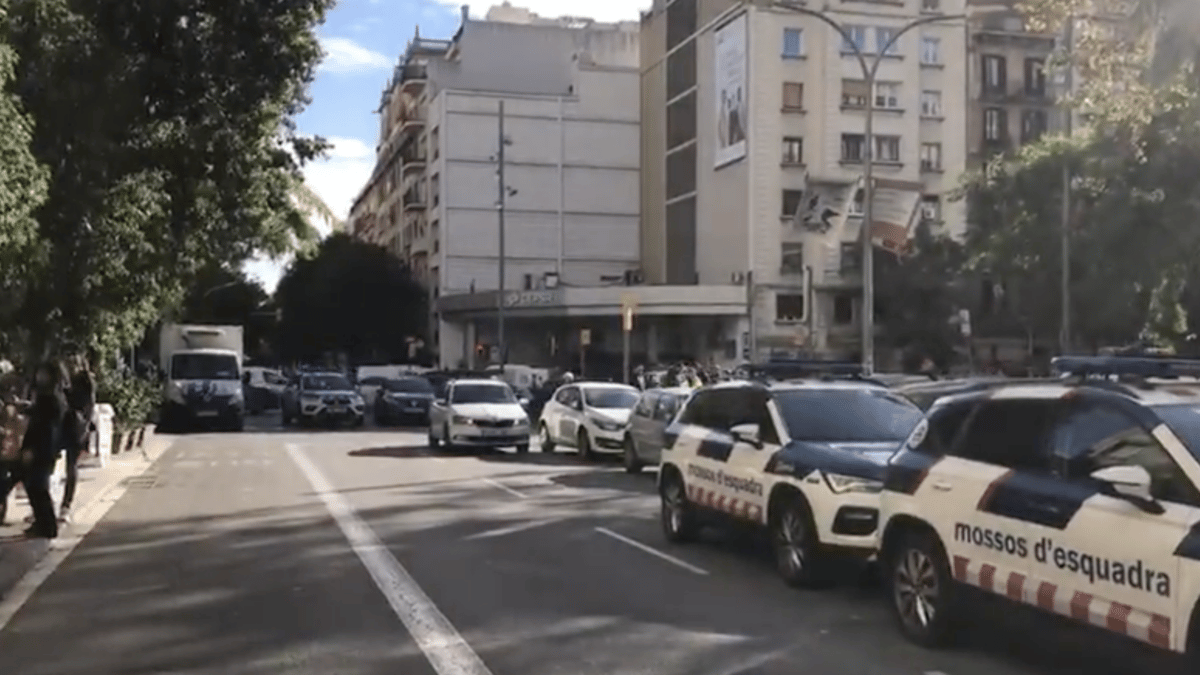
(245, 137, 374, 292)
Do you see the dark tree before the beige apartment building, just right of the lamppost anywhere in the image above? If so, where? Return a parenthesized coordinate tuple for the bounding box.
(875, 222, 966, 366)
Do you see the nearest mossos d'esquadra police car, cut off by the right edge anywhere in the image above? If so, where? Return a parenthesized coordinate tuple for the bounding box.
(881, 357, 1200, 657)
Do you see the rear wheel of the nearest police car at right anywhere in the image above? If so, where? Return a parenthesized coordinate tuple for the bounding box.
(888, 532, 958, 647)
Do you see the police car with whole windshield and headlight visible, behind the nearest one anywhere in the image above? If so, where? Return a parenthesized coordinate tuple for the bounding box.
(659, 362, 922, 586)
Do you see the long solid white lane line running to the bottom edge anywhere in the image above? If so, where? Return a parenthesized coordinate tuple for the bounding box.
(286, 443, 492, 675)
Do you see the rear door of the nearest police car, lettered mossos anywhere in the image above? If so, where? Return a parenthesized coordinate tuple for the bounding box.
(916, 399, 1056, 599)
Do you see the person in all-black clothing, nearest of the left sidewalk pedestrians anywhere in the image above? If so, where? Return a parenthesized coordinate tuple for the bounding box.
(5, 362, 67, 539)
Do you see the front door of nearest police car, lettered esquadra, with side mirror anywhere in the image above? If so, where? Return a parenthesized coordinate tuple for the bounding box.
(1032, 400, 1200, 649)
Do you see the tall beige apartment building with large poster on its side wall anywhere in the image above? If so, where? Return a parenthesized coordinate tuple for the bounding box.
(642, 0, 967, 358)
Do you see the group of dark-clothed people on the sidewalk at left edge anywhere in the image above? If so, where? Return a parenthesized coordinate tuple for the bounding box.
(0, 357, 96, 539)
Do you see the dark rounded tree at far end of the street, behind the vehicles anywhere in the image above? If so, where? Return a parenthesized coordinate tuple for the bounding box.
(275, 233, 428, 362)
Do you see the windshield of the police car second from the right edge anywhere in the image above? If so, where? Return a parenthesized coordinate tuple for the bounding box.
(775, 389, 923, 443)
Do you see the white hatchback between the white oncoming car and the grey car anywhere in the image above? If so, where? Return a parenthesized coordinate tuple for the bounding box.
(538, 382, 642, 459)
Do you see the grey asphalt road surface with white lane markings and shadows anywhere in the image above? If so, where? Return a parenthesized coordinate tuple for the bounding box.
(0, 424, 1182, 675)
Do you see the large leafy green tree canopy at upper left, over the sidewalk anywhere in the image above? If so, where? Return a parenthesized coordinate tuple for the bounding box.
(0, 0, 332, 357)
